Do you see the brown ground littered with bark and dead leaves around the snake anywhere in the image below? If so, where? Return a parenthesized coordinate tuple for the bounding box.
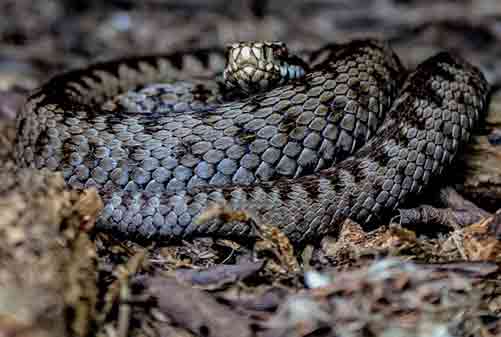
(0, 0, 501, 337)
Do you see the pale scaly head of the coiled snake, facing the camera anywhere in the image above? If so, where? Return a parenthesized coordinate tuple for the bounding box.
(223, 42, 307, 94)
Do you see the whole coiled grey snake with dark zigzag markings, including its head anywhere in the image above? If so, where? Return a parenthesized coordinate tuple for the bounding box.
(15, 39, 489, 243)
